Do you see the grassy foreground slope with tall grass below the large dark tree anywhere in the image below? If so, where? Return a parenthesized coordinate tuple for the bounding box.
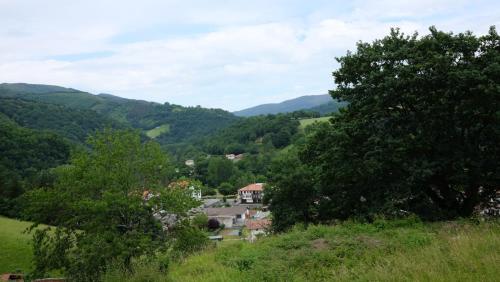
(106, 220, 500, 281)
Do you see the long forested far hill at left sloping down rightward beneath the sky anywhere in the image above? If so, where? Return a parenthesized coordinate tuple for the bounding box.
(0, 83, 239, 144)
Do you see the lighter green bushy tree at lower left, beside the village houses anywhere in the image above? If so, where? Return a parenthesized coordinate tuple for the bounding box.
(25, 130, 197, 281)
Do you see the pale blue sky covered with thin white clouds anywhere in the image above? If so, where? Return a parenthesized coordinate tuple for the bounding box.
(0, 0, 500, 111)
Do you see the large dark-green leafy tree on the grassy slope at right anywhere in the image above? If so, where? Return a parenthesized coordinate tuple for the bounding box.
(302, 27, 500, 218)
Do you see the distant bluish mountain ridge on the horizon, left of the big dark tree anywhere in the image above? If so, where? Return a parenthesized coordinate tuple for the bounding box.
(233, 94, 344, 117)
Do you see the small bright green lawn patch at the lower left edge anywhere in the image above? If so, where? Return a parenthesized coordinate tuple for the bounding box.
(0, 217, 32, 273)
